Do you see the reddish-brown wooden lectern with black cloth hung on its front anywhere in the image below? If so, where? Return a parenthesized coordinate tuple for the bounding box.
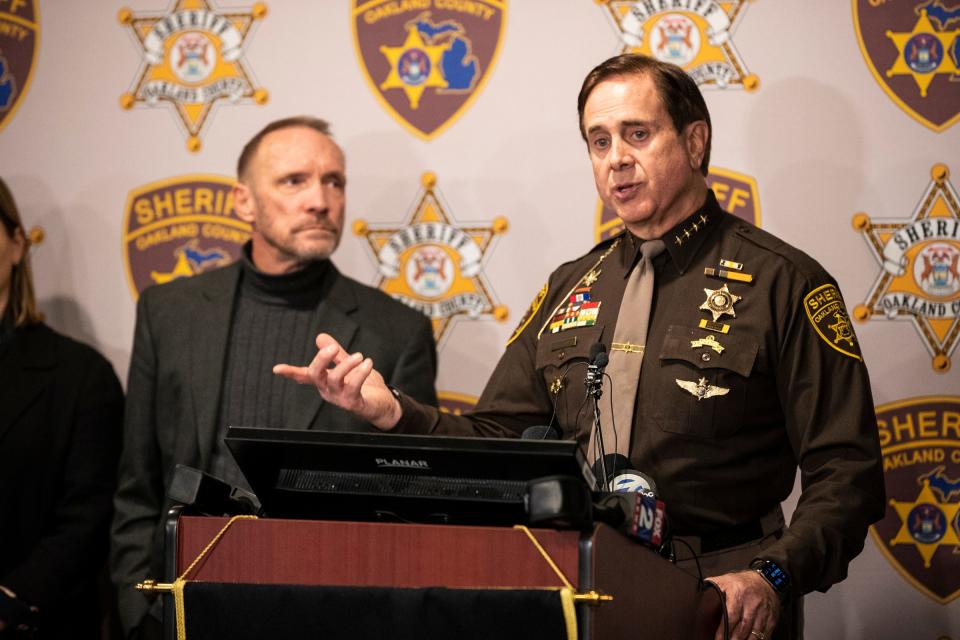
(164, 516, 721, 640)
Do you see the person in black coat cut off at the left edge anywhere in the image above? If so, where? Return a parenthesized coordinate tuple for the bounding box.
(0, 180, 123, 640)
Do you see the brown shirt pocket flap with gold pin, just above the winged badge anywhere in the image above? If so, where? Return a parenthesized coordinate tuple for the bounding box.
(660, 325, 760, 378)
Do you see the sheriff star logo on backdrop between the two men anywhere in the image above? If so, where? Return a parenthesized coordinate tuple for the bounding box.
(353, 172, 509, 344)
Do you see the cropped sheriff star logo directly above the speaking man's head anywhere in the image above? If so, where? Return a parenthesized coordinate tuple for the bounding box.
(594, 0, 760, 91)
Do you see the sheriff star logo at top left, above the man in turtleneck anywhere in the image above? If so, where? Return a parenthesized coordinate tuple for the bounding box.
(118, 0, 268, 152)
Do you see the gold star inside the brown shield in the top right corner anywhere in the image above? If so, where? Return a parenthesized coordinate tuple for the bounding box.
(887, 10, 960, 97)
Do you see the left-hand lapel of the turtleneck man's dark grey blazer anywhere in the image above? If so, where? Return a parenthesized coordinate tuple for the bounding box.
(189, 263, 240, 469)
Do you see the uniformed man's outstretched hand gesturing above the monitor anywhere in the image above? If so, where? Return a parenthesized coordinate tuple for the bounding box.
(273, 333, 401, 431)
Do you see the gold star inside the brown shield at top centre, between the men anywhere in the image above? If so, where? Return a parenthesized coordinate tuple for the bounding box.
(380, 25, 447, 109)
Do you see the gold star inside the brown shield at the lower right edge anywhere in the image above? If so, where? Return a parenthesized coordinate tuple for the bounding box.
(890, 479, 960, 568)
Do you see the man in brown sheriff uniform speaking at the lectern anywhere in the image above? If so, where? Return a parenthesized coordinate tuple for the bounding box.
(275, 55, 884, 640)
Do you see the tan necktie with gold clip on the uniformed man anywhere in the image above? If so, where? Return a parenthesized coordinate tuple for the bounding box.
(587, 240, 664, 473)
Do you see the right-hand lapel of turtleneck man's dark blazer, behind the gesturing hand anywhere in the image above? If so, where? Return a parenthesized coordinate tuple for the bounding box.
(285, 263, 358, 429)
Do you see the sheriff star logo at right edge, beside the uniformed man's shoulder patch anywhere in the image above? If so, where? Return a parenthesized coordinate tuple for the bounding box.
(853, 164, 960, 373)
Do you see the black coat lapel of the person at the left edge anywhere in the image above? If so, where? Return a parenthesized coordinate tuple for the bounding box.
(0, 327, 56, 441)
